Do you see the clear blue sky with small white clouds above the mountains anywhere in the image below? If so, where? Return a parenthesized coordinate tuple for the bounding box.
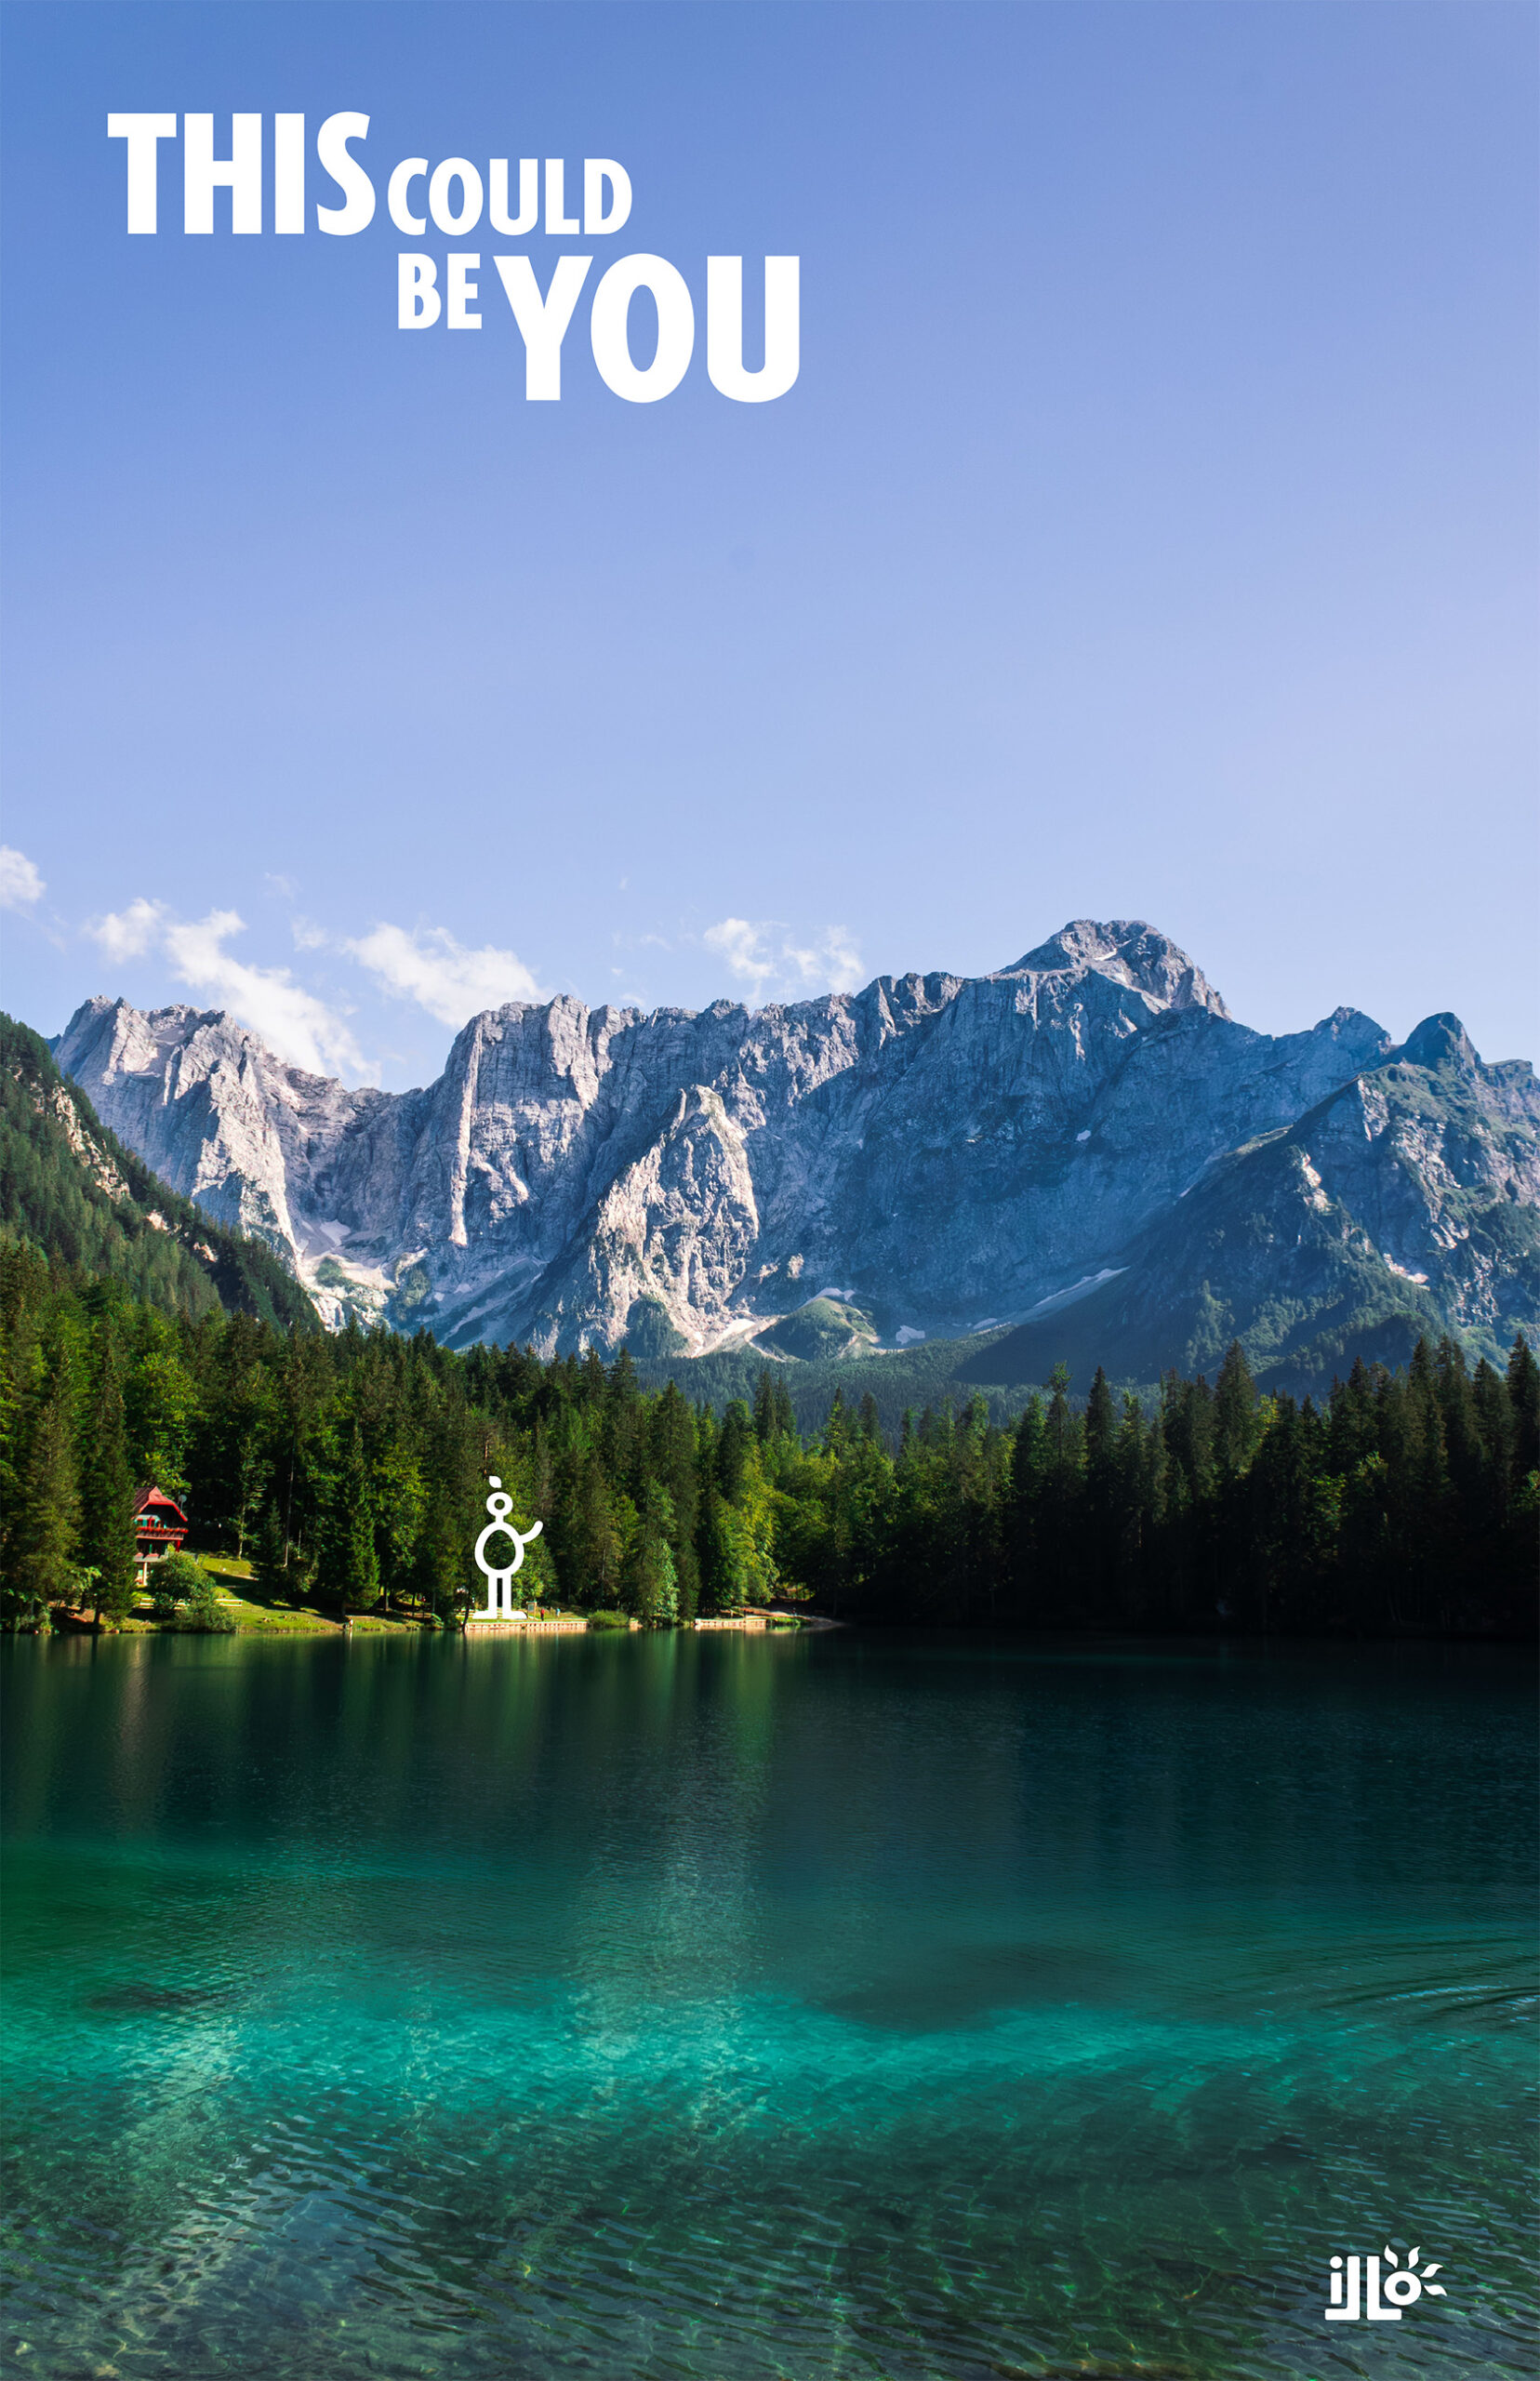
(0, 0, 1537, 1084)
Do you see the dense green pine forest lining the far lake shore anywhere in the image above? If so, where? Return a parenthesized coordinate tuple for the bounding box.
(0, 1238, 1540, 1636)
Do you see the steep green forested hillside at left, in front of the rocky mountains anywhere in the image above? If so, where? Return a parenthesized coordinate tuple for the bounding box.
(0, 1015, 316, 1326)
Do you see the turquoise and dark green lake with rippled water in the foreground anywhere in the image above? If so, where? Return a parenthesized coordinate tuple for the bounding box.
(3, 1631, 1540, 2381)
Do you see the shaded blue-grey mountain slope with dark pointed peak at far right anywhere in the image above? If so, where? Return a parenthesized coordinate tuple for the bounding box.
(959, 1017, 1540, 1390)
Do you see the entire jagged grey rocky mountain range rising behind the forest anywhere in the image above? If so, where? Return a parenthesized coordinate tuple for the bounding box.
(52, 922, 1540, 1381)
